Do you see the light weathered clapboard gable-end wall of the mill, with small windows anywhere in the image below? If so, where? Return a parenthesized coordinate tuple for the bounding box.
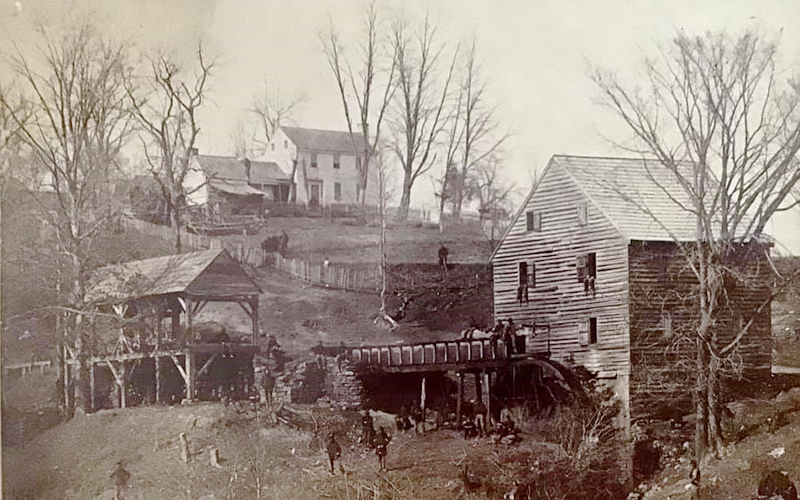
(492, 164, 629, 376)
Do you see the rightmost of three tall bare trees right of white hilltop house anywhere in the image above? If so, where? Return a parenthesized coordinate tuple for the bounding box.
(450, 39, 510, 216)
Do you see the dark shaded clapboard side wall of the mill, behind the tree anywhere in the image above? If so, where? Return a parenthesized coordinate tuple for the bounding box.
(628, 242, 772, 418)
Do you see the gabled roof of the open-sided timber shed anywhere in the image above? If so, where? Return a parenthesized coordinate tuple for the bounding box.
(86, 248, 261, 303)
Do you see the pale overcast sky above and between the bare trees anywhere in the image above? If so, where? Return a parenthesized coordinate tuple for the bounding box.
(0, 0, 800, 255)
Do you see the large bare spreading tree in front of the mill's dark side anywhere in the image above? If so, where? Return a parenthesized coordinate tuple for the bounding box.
(593, 32, 800, 462)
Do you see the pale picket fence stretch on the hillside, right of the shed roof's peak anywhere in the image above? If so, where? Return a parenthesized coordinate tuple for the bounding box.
(275, 254, 380, 292)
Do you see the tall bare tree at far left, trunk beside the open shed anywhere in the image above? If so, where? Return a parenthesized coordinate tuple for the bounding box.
(0, 24, 131, 414)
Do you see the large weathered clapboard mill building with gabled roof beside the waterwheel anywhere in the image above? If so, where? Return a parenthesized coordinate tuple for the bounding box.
(491, 156, 772, 422)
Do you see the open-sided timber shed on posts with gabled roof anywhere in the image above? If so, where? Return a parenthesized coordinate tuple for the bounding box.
(76, 249, 261, 409)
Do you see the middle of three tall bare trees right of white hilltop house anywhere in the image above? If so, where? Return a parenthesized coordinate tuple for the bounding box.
(389, 16, 459, 220)
